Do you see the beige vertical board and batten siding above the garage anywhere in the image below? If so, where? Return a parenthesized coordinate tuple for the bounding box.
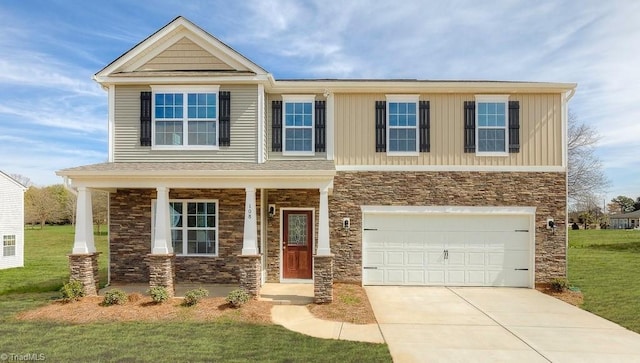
(334, 94, 563, 166)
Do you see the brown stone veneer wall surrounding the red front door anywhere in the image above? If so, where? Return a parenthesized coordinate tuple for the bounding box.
(266, 189, 318, 282)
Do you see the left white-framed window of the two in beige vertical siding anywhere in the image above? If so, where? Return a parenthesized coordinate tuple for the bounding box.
(387, 95, 419, 156)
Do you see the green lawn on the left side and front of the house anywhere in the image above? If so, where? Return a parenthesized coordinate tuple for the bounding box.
(0, 226, 391, 362)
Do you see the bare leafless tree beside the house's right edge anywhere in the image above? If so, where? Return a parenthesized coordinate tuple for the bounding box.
(567, 112, 609, 203)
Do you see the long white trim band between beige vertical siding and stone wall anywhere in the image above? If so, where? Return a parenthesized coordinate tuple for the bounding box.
(336, 165, 567, 173)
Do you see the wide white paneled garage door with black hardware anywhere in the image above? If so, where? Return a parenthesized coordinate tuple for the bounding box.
(363, 213, 533, 287)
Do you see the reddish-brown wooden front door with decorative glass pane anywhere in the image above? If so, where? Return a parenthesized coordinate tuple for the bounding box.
(282, 210, 313, 279)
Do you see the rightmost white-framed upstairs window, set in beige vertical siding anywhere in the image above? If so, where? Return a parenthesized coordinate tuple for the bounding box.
(476, 95, 509, 156)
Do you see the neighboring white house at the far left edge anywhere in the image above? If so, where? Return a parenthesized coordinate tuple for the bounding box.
(0, 171, 27, 269)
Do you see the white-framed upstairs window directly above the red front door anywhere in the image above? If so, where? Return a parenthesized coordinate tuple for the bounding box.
(282, 95, 315, 156)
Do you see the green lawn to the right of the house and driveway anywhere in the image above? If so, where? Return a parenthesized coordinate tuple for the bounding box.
(568, 230, 640, 333)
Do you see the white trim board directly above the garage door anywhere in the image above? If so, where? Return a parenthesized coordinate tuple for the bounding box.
(360, 205, 536, 216)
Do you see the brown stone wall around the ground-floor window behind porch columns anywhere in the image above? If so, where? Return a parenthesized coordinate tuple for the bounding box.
(109, 189, 260, 284)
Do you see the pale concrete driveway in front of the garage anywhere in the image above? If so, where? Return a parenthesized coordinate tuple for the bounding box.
(366, 286, 640, 363)
